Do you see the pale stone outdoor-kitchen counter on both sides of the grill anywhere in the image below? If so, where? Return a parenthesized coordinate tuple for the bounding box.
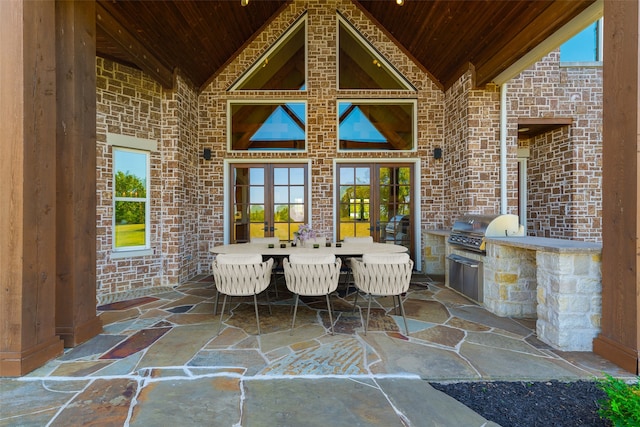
(425, 230, 602, 351)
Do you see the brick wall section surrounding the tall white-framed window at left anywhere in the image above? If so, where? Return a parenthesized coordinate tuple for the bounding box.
(96, 58, 162, 299)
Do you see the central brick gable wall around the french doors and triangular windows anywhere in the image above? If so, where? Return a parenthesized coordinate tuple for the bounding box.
(199, 0, 444, 271)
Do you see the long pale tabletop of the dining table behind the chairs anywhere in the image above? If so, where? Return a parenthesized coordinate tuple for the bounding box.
(209, 243, 408, 256)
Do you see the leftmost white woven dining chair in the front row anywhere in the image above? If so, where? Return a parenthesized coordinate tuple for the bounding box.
(211, 254, 273, 335)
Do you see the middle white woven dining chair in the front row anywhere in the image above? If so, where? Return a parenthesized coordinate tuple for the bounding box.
(283, 254, 342, 335)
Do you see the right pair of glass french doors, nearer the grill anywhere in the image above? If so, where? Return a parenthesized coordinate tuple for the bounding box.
(337, 163, 414, 253)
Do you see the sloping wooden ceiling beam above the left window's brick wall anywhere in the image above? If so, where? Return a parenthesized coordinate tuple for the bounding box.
(96, 2, 174, 89)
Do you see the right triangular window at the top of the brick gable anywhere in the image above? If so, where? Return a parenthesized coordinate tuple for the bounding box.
(338, 16, 415, 90)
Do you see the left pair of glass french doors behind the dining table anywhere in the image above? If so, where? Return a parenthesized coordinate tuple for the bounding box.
(230, 163, 308, 243)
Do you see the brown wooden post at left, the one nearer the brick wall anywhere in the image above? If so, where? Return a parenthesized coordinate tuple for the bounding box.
(55, 1, 102, 347)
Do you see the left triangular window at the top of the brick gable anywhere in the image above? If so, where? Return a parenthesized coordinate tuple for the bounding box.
(231, 17, 307, 90)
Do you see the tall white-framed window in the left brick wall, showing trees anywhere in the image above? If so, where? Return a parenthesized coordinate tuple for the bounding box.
(113, 147, 150, 251)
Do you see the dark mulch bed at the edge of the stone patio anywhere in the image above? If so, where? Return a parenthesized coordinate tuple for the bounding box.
(431, 380, 611, 427)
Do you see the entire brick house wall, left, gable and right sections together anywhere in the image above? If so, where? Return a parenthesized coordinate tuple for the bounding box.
(96, 0, 602, 298)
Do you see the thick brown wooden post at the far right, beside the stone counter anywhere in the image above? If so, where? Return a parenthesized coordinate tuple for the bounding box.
(593, 0, 640, 375)
